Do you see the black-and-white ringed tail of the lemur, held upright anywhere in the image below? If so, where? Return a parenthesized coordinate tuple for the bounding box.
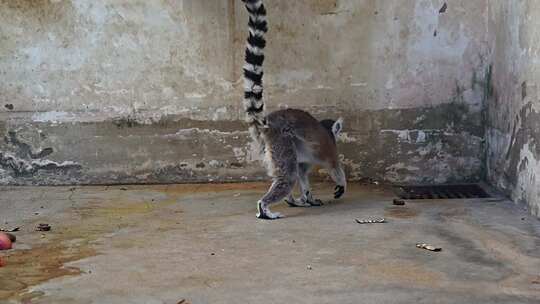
(242, 0, 268, 125)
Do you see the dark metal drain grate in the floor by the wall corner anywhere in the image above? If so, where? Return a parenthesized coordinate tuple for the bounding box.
(396, 184, 490, 200)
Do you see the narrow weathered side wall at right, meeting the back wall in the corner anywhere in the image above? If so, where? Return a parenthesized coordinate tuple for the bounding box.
(487, 0, 540, 216)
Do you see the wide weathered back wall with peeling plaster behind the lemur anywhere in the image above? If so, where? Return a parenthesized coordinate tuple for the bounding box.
(0, 0, 488, 184)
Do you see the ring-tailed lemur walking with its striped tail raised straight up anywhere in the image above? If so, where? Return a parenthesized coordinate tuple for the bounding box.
(242, 0, 347, 219)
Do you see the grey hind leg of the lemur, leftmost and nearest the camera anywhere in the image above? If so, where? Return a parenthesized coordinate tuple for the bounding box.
(257, 136, 298, 219)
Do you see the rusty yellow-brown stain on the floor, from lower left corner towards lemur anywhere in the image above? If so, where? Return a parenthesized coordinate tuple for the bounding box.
(0, 183, 267, 302)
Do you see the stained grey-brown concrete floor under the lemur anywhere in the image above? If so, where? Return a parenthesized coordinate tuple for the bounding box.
(0, 184, 540, 304)
